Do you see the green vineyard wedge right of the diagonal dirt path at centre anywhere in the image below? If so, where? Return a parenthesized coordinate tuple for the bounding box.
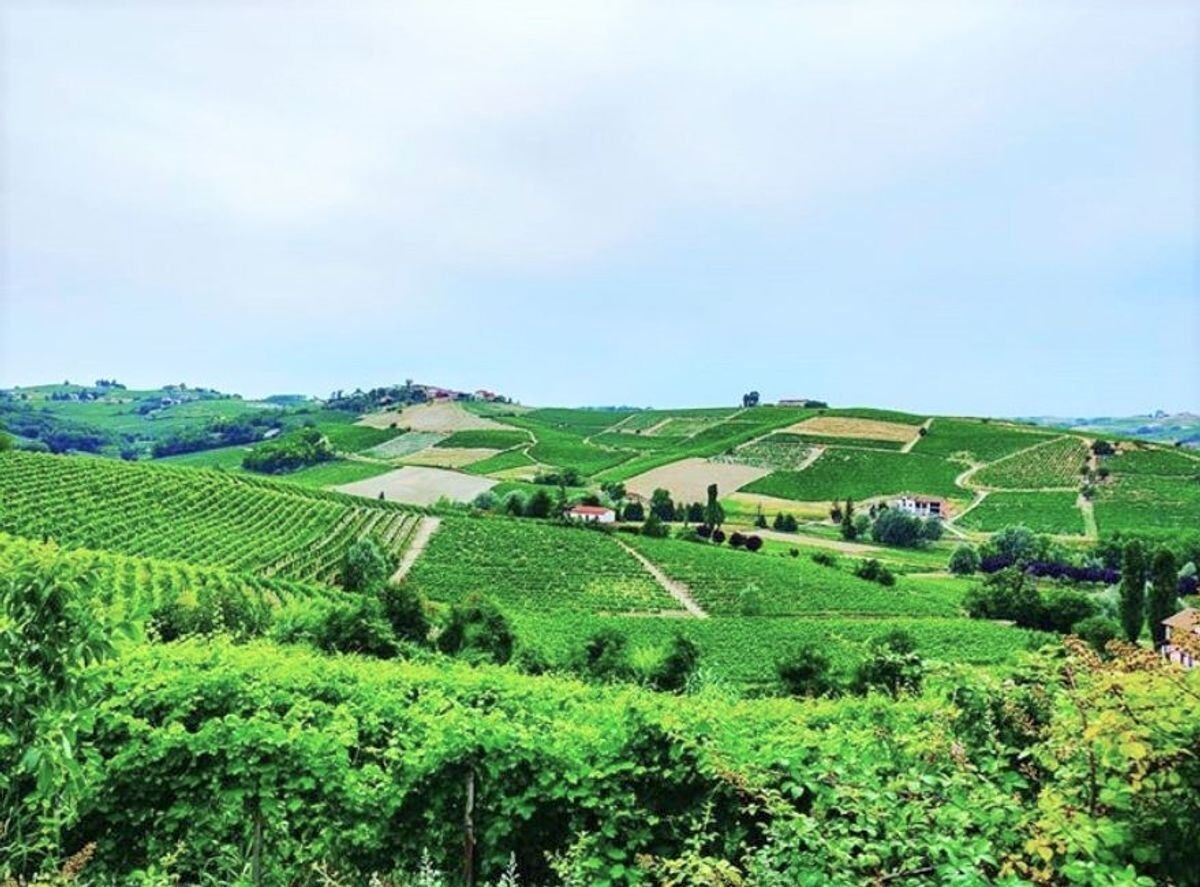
(629, 537, 961, 616)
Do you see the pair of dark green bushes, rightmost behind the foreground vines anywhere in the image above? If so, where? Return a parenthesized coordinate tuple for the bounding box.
(775, 629, 925, 696)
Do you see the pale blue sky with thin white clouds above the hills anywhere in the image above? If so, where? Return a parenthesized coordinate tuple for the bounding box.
(0, 0, 1200, 416)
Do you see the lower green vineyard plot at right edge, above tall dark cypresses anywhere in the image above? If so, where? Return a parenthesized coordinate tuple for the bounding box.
(1096, 475, 1200, 533)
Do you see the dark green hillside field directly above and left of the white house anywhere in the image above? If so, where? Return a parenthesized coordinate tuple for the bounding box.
(743, 448, 965, 502)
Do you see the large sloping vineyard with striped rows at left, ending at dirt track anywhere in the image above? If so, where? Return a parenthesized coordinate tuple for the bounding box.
(0, 453, 416, 581)
